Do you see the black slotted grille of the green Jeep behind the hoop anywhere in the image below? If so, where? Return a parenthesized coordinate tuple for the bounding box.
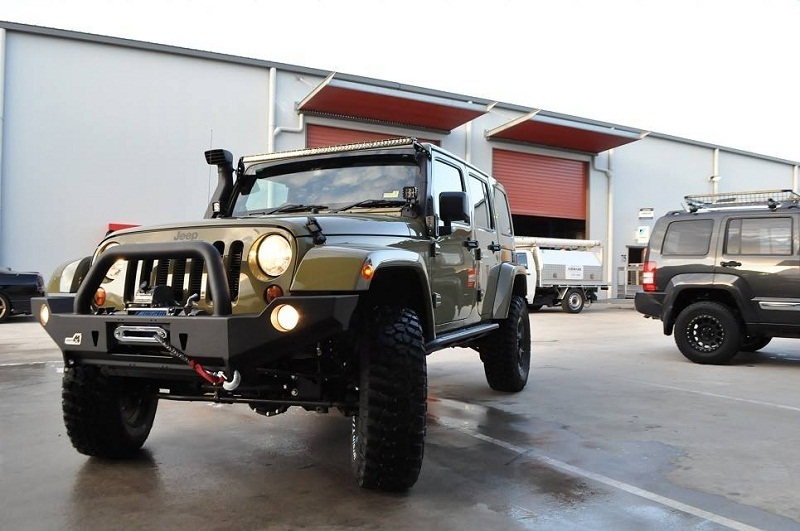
(124, 241, 244, 303)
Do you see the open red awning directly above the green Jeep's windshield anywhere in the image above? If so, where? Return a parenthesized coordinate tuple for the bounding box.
(297, 74, 486, 133)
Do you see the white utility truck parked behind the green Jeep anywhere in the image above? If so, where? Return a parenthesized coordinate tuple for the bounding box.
(514, 236, 608, 313)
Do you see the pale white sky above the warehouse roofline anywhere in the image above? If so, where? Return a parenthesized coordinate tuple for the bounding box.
(0, 0, 800, 161)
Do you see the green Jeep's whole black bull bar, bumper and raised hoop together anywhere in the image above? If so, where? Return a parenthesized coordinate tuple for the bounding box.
(33, 242, 358, 372)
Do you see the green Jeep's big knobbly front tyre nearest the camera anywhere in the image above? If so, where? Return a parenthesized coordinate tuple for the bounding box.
(352, 307, 428, 491)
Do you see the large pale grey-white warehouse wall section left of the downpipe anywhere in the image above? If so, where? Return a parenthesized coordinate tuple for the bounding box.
(0, 32, 268, 277)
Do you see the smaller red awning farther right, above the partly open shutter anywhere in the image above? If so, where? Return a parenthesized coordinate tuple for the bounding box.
(486, 110, 647, 155)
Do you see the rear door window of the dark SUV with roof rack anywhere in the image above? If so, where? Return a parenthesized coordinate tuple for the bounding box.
(725, 218, 792, 255)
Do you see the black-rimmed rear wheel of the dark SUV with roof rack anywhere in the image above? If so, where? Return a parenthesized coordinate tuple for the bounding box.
(675, 301, 742, 365)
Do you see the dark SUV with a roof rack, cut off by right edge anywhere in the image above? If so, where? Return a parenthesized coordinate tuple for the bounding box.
(636, 190, 800, 364)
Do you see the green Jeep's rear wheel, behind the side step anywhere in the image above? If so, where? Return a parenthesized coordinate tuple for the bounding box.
(480, 296, 531, 393)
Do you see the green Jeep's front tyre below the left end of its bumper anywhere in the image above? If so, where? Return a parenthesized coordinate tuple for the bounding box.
(61, 367, 158, 459)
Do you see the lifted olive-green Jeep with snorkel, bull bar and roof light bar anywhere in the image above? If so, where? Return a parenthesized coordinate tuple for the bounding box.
(34, 139, 531, 491)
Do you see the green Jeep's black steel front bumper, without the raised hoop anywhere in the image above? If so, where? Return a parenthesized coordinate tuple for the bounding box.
(33, 295, 358, 371)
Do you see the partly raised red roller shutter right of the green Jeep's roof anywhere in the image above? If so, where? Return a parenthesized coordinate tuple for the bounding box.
(492, 149, 587, 220)
